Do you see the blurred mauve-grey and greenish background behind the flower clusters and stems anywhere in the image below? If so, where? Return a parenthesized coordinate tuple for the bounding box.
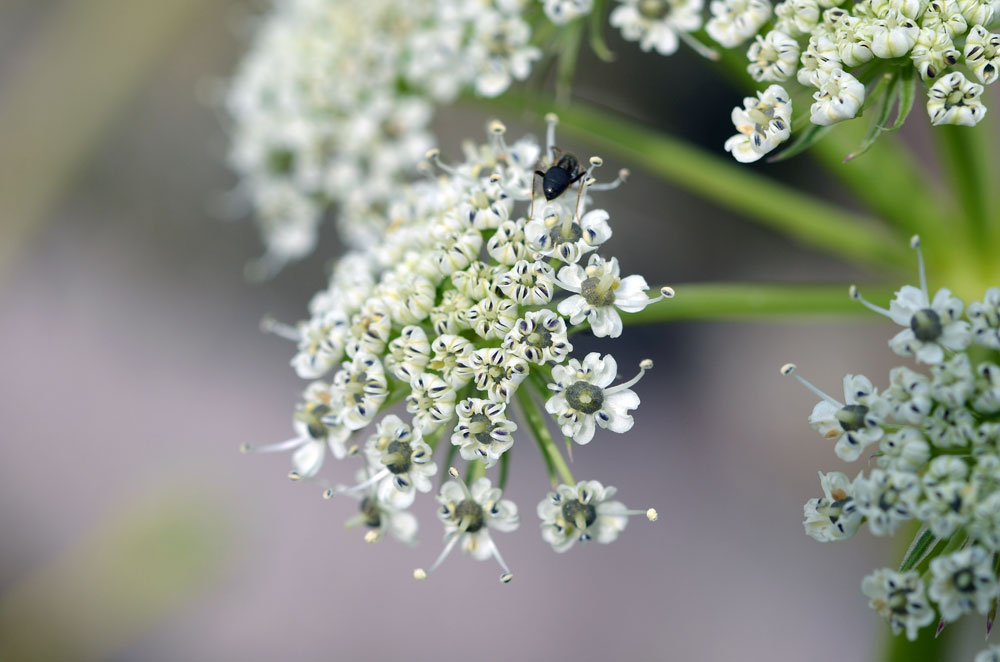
(0, 0, 984, 662)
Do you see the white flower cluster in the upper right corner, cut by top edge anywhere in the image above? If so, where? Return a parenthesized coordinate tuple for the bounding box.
(610, 0, 1000, 163)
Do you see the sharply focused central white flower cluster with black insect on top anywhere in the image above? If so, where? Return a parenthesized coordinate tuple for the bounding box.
(245, 115, 673, 581)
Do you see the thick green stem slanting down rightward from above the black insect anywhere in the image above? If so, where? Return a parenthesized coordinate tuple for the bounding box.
(490, 93, 912, 268)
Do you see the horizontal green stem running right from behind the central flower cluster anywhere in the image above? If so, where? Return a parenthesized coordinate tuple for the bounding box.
(622, 283, 892, 326)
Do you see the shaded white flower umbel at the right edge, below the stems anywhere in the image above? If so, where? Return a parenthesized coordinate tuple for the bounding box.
(781, 237, 1000, 662)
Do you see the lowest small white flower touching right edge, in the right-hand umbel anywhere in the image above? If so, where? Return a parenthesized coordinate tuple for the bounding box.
(927, 545, 1000, 621)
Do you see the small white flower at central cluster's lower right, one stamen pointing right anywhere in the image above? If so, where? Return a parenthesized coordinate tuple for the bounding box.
(537, 480, 656, 552)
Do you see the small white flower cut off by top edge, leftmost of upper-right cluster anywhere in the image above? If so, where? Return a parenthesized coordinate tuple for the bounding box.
(609, 0, 702, 55)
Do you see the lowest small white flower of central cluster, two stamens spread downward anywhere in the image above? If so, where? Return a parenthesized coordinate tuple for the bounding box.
(413, 469, 521, 583)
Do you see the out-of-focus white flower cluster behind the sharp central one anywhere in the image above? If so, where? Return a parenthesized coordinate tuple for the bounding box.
(227, 0, 542, 276)
